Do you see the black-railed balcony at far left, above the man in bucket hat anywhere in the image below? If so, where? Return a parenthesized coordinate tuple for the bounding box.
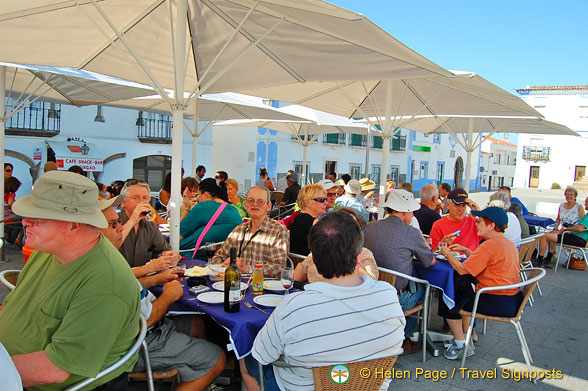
(5, 99, 61, 137)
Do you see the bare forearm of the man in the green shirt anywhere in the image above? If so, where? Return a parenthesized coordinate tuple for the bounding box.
(11, 351, 70, 387)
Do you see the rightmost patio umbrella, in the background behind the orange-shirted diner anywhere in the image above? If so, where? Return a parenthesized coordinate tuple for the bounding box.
(400, 116, 579, 191)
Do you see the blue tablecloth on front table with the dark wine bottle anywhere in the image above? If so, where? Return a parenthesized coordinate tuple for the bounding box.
(150, 260, 282, 358)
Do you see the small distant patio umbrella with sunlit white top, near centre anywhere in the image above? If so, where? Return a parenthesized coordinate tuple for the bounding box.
(215, 105, 379, 184)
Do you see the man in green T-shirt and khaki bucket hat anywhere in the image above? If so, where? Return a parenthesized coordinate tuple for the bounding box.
(0, 171, 140, 390)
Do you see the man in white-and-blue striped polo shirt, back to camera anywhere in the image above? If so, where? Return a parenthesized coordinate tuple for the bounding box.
(244, 211, 405, 391)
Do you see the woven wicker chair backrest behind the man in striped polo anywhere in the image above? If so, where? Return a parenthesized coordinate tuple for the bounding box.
(312, 356, 398, 391)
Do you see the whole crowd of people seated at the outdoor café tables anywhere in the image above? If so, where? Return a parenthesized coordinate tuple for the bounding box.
(0, 166, 568, 390)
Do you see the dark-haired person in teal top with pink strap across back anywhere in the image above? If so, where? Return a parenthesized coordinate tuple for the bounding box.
(180, 178, 243, 256)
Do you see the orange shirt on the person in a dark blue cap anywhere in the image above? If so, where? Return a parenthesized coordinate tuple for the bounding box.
(463, 236, 521, 296)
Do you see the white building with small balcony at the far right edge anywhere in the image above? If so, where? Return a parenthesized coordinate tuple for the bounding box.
(514, 85, 588, 189)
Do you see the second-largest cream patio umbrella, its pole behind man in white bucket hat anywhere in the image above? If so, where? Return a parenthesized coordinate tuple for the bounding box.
(241, 71, 542, 217)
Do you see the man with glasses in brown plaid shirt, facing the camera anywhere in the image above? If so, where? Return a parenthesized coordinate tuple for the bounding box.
(211, 186, 290, 277)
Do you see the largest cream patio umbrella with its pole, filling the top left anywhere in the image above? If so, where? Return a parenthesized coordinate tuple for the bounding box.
(0, 0, 450, 249)
